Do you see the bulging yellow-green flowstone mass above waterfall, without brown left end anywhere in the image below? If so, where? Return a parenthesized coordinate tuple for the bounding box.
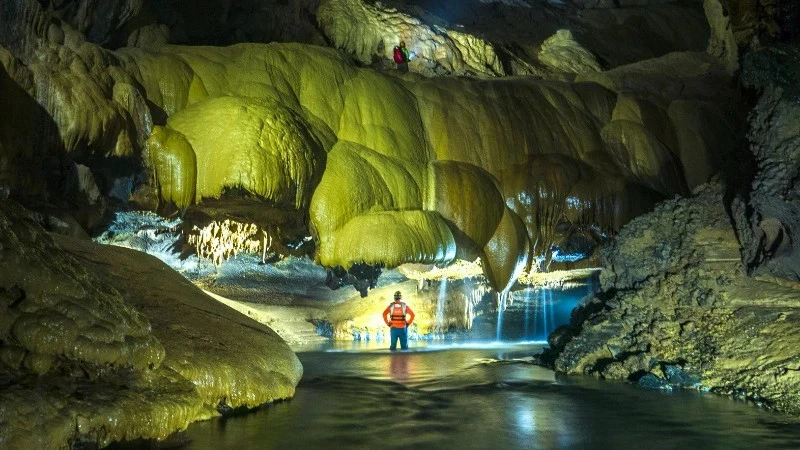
(118, 45, 736, 290)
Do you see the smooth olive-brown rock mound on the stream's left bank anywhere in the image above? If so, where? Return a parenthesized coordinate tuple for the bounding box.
(0, 199, 302, 449)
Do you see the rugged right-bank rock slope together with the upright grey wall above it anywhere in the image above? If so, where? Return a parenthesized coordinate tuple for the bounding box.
(544, 44, 800, 414)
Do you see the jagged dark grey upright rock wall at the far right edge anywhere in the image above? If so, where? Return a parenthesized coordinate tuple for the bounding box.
(735, 49, 800, 281)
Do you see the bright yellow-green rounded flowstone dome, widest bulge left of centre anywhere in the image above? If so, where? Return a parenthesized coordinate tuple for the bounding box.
(167, 97, 325, 209)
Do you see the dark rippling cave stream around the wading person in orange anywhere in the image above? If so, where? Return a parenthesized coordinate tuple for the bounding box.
(162, 343, 800, 449)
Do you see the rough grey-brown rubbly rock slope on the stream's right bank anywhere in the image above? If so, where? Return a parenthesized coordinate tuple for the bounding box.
(543, 180, 800, 414)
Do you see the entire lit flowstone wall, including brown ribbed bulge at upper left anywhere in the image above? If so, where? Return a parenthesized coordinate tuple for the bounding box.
(0, 2, 733, 296)
